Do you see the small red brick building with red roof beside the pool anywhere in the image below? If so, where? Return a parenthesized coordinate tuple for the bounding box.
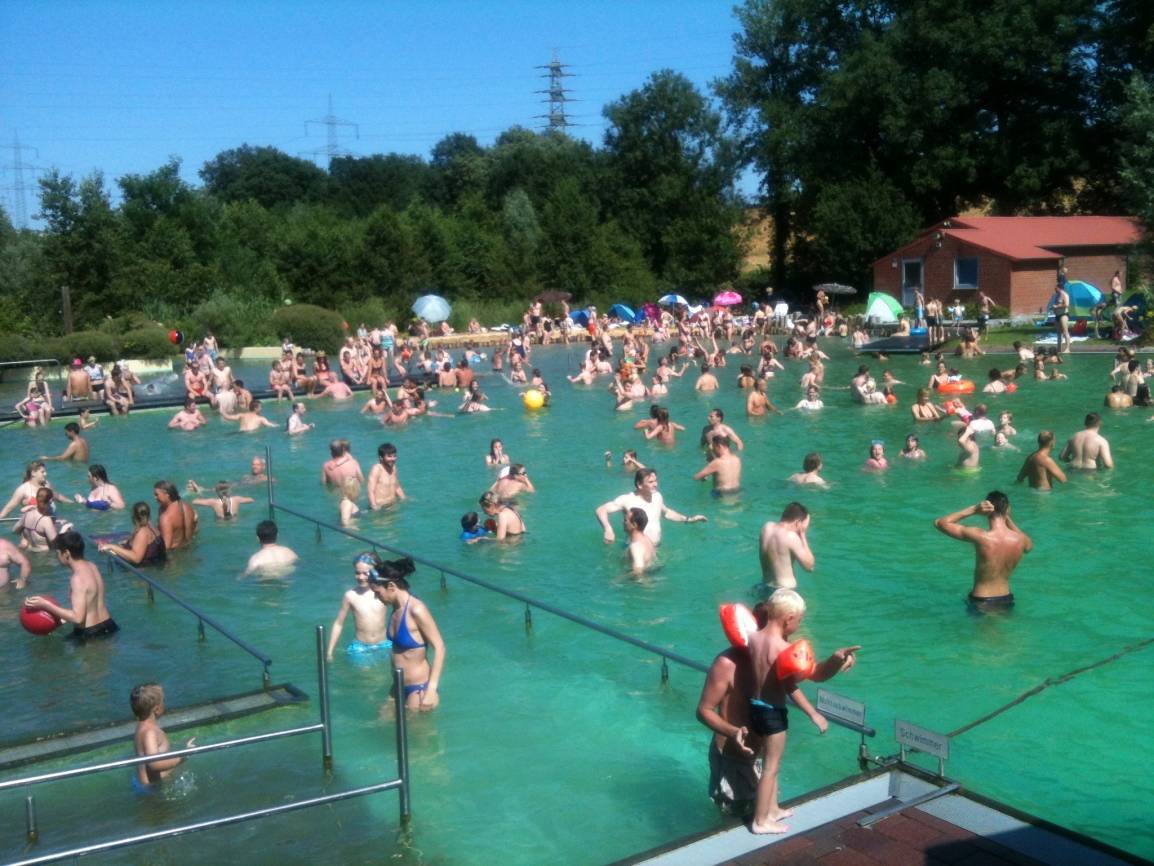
(874, 216, 1141, 315)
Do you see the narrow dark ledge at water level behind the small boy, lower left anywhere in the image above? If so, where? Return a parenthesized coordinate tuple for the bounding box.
(0, 682, 308, 771)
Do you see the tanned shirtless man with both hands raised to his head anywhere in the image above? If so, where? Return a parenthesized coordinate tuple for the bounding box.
(934, 491, 1034, 613)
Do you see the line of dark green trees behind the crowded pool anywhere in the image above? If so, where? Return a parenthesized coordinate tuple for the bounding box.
(0, 0, 1154, 344)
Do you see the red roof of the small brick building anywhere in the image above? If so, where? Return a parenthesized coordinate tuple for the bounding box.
(929, 216, 1141, 260)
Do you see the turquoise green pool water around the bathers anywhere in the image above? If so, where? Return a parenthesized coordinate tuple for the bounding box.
(0, 348, 1154, 864)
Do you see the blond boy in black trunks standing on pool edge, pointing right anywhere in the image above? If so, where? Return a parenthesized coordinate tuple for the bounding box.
(749, 589, 861, 834)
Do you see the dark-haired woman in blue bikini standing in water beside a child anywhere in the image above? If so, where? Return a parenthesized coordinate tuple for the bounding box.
(369, 559, 444, 710)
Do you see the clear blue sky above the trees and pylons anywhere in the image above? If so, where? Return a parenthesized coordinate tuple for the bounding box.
(0, 0, 736, 225)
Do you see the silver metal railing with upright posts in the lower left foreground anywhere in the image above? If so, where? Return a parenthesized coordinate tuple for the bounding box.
(0, 626, 412, 866)
